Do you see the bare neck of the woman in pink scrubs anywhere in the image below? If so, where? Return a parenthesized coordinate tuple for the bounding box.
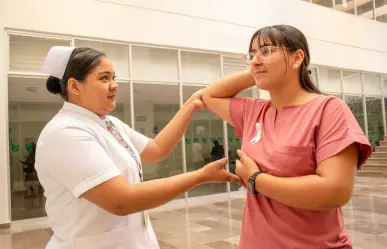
(269, 79, 306, 111)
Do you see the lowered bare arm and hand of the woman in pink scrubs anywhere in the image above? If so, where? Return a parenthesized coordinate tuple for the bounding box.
(237, 145, 358, 211)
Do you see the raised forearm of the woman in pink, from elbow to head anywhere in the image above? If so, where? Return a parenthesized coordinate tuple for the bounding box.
(203, 70, 255, 101)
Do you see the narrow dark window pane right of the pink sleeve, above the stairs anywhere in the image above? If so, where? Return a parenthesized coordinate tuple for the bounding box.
(366, 97, 384, 146)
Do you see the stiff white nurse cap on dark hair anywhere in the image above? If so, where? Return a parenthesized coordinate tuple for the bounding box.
(43, 46, 75, 79)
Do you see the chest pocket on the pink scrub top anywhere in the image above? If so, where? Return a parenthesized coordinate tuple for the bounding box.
(271, 146, 316, 177)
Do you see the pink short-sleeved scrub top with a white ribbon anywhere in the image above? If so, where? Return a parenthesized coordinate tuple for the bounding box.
(230, 95, 372, 249)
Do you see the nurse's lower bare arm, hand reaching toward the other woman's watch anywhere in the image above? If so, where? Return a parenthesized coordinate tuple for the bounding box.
(81, 159, 240, 216)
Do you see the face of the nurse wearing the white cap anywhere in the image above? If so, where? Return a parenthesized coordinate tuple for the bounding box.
(69, 57, 118, 116)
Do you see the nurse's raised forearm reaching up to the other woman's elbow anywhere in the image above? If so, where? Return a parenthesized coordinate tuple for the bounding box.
(154, 103, 195, 160)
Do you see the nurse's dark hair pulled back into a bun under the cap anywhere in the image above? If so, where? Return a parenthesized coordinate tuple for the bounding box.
(46, 48, 106, 101)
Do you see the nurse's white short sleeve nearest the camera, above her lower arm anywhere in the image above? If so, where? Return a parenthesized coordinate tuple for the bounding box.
(36, 126, 121, 198)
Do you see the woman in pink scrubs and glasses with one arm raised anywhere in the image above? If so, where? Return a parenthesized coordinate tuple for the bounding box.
(202, 25, 372, 249)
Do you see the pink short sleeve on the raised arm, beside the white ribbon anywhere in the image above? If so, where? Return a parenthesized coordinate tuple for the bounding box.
(229, 97, 266, 138)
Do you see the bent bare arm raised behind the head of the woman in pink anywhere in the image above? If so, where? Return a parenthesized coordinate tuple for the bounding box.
(202, 71, 255, 125)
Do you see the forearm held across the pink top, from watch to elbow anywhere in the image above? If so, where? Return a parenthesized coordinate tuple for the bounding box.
(255, 174, 351, 211)
